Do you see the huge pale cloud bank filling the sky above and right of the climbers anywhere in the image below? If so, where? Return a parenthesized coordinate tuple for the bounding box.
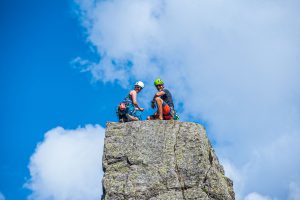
(77, 0, 300, 199)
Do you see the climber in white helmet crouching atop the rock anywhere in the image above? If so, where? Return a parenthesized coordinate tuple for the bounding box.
(117, 81, 144, 122)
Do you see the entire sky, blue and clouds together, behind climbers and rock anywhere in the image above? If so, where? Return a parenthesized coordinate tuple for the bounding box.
(0, 0, 300, 200)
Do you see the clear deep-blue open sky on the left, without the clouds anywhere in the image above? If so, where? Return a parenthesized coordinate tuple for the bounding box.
(0, 1, 126, 199)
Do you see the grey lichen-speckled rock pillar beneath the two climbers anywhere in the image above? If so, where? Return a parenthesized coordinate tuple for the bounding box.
(102, 120, 235, 200)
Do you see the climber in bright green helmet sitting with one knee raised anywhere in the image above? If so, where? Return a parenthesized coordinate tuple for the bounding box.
(147, 78, 178, 120)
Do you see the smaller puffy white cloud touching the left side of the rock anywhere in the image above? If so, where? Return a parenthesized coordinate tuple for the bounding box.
(26, 125, 104, 200)
